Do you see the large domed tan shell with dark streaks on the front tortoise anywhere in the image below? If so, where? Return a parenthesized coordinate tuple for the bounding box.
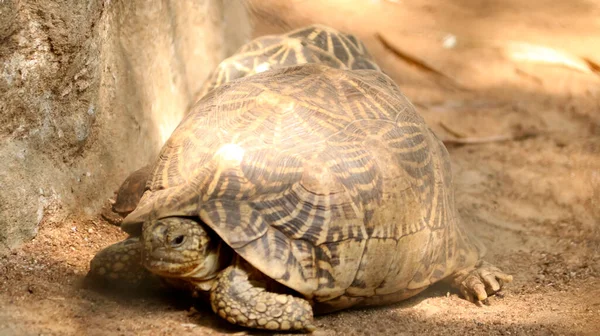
(123, 64, 478, 301)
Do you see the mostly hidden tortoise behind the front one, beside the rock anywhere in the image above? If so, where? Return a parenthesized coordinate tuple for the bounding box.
(102, 24, 381, 217)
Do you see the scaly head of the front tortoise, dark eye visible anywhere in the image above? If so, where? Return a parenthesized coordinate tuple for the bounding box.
(142, 217, 226, 281)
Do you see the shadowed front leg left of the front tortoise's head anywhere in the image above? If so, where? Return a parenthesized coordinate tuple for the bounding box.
(88, 237, 153, 288)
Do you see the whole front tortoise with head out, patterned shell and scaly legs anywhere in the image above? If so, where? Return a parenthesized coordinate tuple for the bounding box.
(91, 27, 512, 331)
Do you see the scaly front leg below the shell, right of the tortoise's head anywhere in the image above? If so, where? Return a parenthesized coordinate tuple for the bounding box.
(210, 263, 316, 332)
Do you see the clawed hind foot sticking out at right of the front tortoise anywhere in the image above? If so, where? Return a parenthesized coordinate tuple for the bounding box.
(449, 260, 513, 302)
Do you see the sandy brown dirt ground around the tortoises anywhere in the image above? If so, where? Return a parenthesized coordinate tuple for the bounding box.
(0, 0, 600, 335)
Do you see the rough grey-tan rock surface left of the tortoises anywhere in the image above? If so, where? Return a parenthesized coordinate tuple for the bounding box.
(0, 0, 250, 254)
